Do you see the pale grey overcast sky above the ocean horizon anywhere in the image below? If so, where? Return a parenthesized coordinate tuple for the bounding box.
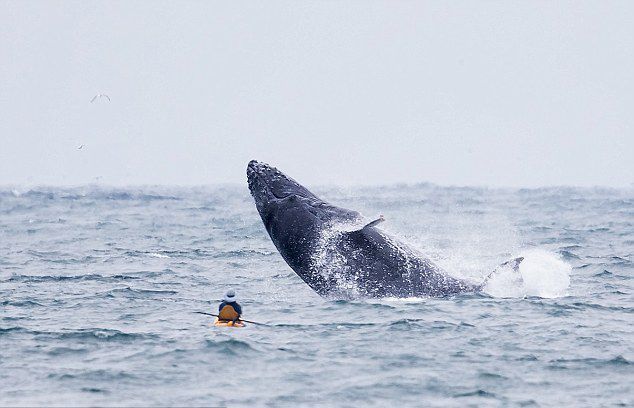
(0, 0, 634, 186)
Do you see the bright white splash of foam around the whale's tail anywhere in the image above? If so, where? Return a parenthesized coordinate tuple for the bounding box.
(484, 249, 572, 298)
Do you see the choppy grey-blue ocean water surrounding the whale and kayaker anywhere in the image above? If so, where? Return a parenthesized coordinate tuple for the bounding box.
(0, 183, 634, 407)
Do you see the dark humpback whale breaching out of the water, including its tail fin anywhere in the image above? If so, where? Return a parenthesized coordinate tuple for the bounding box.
(247, 160, 522, 298)
